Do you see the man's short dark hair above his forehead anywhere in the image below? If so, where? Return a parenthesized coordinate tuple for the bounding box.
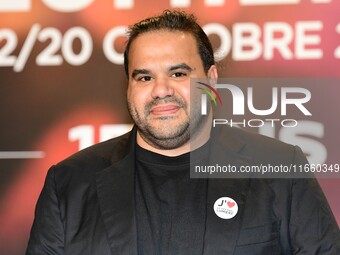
(124, 10, 215, 79)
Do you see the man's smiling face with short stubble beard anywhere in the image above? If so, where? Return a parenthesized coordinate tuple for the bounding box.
(127, 30, 216, 150)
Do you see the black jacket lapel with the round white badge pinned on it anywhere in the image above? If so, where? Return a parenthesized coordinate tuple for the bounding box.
(204, 128, 250, 255)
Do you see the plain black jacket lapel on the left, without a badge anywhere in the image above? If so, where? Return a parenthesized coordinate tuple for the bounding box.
(96, 131, 137, 254)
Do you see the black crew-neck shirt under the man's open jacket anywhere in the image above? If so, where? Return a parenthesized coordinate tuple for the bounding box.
(136, 145, 208, 255)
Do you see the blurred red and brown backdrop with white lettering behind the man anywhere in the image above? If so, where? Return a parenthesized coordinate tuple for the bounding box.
(0, 0, 340, 255)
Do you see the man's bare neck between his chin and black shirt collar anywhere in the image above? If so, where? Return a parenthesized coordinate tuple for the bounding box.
(137, 112, 212, 157)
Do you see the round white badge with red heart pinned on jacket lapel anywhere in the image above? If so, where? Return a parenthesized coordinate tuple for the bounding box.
(214, 197, 238, 220)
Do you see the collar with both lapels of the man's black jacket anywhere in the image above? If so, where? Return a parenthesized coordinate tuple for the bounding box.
(96, 127, 249, 255)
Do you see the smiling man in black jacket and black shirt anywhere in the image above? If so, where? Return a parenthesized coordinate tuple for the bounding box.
(27, 11, 340, 255)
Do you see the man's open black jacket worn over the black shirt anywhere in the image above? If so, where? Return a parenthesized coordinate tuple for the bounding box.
(26, 127, 340, 255)
